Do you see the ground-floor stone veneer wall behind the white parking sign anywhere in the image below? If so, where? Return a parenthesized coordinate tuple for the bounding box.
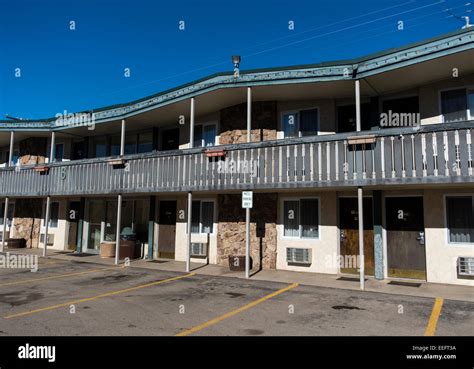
(217, 193, 278, 270)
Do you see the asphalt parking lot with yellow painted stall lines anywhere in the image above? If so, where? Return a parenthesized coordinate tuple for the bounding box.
(0, 259, 474, 336)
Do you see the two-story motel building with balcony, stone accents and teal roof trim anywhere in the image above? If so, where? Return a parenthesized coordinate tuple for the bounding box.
(0, 28, 474, 286)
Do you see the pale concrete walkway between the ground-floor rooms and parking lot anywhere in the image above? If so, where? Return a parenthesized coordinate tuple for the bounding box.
(5, 248, 474, 302)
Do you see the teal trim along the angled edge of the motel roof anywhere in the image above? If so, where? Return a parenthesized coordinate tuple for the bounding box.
(0, 28, 474, 131)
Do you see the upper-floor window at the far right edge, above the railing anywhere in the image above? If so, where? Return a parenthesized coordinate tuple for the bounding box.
(441, 88, 474, 123)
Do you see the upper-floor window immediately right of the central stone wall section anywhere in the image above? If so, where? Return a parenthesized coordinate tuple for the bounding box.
(283, 109, 319, 138)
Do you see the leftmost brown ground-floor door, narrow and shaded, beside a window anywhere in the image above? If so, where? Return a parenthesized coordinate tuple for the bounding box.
(158, 201, 176, 259)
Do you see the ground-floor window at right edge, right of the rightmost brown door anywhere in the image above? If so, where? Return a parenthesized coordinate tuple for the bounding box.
(446, 196, 474, 243)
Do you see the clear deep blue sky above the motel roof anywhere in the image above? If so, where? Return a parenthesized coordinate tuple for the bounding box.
(0, 0, 474, 119)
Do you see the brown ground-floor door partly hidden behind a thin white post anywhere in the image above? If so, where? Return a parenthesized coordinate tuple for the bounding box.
(339, 197, 375, 275)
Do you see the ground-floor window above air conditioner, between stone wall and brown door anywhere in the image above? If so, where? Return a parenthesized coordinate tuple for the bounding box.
(283, 199, 319, 238)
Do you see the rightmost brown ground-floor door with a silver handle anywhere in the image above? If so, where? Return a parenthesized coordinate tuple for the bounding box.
(385, 197, 426, 279)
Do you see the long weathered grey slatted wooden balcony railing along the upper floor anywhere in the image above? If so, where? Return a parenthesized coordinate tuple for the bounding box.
(0, 121, 474, 197)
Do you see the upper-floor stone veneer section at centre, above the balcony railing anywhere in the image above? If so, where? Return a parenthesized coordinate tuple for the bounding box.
(219, 101, 278, 145)
